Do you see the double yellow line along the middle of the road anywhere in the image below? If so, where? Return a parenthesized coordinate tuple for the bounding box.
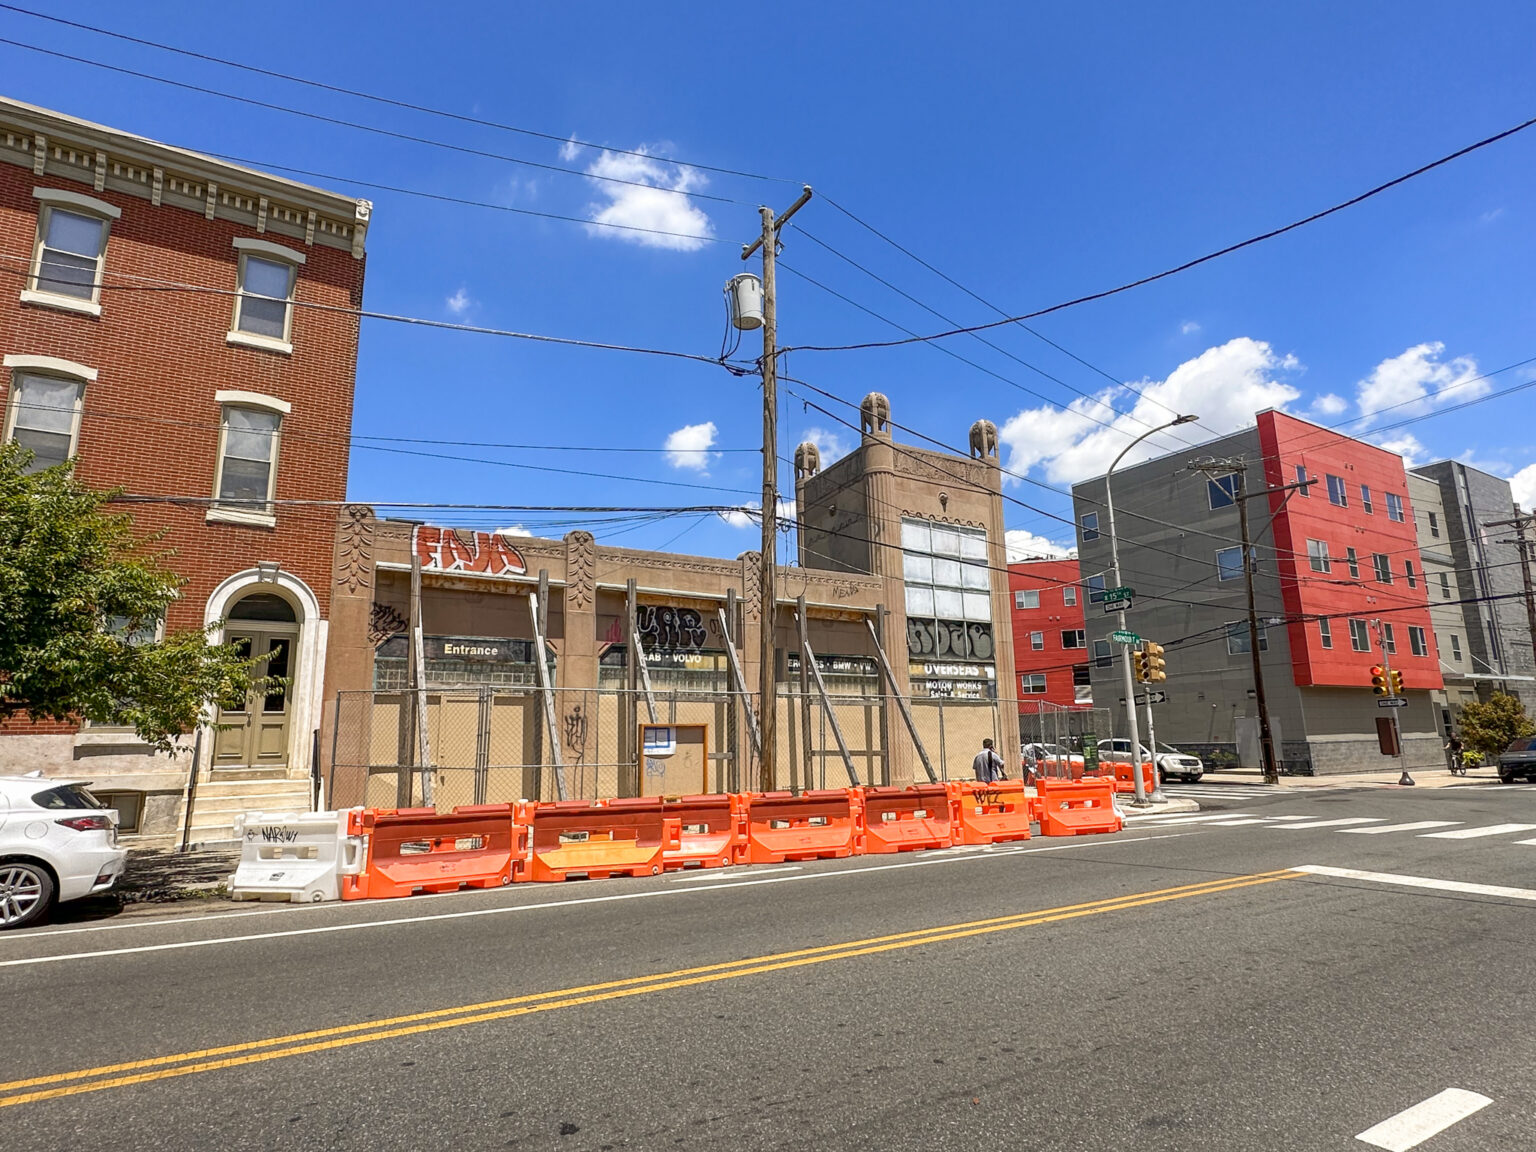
(0, 868, 1299, 1107)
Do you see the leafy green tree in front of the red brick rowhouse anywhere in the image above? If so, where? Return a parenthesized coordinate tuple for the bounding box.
(0, 444, 261, 750)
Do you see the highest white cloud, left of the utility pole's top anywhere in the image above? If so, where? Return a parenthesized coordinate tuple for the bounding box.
(577, 141, 714, 252)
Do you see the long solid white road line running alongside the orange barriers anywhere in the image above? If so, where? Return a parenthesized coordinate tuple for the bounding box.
(0, 828, 1201, 968)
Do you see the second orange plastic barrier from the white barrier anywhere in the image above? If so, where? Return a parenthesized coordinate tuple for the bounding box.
(518, 797, 665, 882)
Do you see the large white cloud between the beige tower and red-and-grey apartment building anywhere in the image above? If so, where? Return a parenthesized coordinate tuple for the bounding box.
(998, 336, 1301, 484)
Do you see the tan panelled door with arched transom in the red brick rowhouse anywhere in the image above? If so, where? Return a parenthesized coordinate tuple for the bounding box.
(214, 591, 300, 768)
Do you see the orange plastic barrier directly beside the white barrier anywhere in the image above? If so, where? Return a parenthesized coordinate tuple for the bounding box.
(341, 803, 528, 900)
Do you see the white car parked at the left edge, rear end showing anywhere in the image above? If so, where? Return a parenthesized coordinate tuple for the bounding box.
(0, 776, 127, 929)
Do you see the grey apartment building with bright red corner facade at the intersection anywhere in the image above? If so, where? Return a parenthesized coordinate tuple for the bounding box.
(1074, 410, 1442, 774)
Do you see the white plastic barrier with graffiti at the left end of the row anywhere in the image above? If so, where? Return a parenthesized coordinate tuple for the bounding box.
(229, 808, 366, 903)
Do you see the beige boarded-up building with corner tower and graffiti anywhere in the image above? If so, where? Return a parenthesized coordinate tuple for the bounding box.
(321, 393, 1018, 806)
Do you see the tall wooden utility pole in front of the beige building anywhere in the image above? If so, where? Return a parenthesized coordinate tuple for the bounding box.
(742, 184, 811, 791)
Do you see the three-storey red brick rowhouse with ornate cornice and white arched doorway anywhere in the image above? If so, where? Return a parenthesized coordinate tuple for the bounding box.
(0, 100, 370, 839)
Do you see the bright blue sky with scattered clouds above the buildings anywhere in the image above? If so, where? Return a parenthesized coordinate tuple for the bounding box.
(0, 0, 1536, 556)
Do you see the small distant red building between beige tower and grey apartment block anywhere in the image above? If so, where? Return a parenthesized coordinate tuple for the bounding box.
(1008, 559, 1094, 711)
